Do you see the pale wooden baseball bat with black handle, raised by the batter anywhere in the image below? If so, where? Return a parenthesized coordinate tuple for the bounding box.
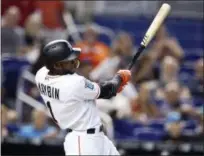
(128, 3, 171, 70)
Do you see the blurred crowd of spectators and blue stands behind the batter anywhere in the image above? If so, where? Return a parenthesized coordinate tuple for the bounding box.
(1, 0, 204, 156)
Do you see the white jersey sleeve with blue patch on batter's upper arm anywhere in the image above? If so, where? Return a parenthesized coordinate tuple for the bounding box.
(75, 78, 100, 100)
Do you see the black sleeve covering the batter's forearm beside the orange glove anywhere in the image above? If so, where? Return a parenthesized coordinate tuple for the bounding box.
(98, 75, 122, 99)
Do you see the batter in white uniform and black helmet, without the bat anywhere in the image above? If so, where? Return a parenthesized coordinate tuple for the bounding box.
(35, 40, 131, 155)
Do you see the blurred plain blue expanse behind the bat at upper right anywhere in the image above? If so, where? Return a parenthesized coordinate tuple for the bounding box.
(94, 15, 203, 49)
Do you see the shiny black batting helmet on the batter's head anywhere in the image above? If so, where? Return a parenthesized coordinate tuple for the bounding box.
(43, 40, 81, 69)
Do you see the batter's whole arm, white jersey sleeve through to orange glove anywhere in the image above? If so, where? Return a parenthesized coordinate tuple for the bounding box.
(75, 70, 131, 100)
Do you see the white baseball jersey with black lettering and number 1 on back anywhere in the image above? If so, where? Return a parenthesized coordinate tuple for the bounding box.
(35, 67, 102, 131)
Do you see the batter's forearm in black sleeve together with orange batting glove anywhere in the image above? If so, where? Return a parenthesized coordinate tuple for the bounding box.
(98, 70, 131, 99)
